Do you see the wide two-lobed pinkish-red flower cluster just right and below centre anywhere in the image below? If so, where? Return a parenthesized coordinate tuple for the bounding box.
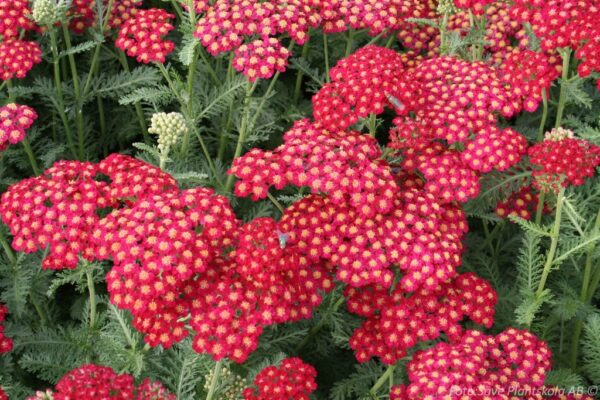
(281, 189, 467, 291)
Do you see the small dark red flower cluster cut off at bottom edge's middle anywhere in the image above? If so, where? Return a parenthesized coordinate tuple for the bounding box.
(243, 357, 317, 400)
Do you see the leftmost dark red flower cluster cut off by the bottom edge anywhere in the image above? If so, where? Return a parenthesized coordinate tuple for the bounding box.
(28, 364, 175, 400)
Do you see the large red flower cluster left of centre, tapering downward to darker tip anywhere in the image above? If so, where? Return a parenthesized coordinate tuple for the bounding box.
(92, 189, 238, 348)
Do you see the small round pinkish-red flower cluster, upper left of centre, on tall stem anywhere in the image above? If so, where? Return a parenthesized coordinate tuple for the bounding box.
(233, 38, 290, 82)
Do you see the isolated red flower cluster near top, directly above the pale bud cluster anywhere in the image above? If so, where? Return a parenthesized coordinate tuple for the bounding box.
(115, 8, 175, 64)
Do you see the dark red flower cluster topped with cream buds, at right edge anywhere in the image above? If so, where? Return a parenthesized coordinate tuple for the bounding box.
(529, 128, 600, 191)
